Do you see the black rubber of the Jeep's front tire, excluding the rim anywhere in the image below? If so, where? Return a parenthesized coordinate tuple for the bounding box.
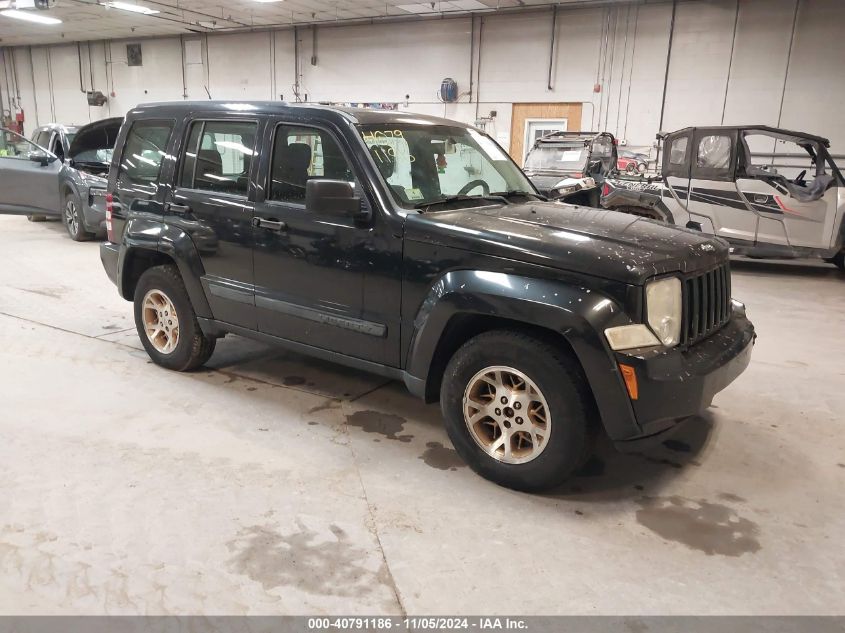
(440, 330, 594, 492)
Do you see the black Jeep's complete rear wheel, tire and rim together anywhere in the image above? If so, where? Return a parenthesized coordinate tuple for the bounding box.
(134, 265, 217, 371)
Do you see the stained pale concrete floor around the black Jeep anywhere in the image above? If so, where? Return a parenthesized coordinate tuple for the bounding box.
(0, 216, 845, 614)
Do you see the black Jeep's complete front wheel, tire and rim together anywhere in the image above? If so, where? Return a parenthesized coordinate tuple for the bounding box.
(440, 330, 592, 492)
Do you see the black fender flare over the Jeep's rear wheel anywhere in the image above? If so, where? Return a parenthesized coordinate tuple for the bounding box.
(117, 215, 213, 319)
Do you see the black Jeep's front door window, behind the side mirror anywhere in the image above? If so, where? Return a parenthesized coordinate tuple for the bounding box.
(270, 125, 355, 204)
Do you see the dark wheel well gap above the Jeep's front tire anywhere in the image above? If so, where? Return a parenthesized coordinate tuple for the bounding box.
(425, 314, 592, 402)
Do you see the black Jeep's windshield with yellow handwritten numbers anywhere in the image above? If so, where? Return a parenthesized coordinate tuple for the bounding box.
(358, 122, 536, 208)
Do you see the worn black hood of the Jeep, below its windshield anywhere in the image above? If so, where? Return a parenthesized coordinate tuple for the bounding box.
(406, 202, 728, 285)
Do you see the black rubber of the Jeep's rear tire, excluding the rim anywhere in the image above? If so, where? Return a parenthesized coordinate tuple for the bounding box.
(134, 265, 217, 371)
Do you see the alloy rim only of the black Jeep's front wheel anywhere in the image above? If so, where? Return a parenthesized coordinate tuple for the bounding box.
(463, 366, 552, 464)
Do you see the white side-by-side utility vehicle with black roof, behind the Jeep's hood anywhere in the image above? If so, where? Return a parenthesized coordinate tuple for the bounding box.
(601, 126, 845, 268)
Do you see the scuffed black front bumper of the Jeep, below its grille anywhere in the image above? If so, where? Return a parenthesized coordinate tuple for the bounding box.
(615, 309, 757, 450)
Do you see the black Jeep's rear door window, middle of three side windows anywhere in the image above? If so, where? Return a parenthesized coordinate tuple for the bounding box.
(179, 121, 258, 196)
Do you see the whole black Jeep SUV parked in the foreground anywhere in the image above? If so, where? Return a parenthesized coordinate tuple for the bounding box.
(100, 102, 754, 490)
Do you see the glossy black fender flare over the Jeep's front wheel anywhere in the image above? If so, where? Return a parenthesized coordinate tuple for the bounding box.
(405, 270, 640, 437)
